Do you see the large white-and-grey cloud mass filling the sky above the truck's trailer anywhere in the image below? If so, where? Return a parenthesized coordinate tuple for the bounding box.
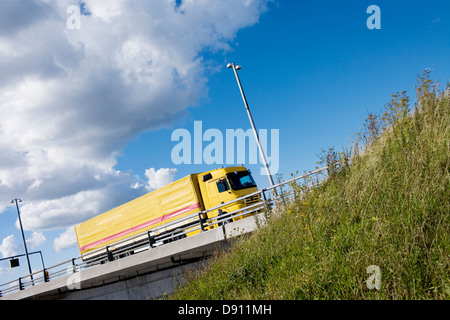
(0, 0, 266, 236)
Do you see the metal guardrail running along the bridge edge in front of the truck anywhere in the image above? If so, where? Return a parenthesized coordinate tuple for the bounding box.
(0, 163, 340, 297)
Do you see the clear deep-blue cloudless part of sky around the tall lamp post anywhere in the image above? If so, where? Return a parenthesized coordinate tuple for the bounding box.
(115, 1, 450, 186)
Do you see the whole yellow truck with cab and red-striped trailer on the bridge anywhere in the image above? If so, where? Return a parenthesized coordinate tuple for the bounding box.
(75, 166, 261, 260)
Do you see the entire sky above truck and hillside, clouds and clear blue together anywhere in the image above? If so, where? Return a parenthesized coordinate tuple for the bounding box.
(0, 0, 450, 282)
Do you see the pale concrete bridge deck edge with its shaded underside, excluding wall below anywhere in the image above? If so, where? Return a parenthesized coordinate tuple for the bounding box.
(0, 214, 263, 300)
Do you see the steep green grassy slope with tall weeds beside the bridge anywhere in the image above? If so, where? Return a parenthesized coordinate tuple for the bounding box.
(170, 72, 450, 300)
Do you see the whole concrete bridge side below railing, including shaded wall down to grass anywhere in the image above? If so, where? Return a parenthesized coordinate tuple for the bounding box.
(0, 214, 264, 300)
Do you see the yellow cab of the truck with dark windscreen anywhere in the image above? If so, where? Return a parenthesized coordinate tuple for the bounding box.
(198, 166, 261, 221)
